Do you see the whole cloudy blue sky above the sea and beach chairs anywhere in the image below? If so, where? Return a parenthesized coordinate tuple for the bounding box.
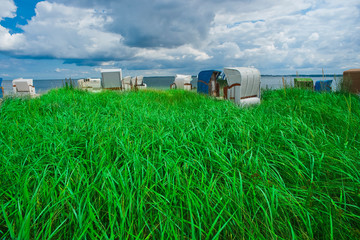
(0, 0, 360, 80)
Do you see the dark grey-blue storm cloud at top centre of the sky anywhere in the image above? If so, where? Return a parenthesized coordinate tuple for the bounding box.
(56, 0, 215, 48)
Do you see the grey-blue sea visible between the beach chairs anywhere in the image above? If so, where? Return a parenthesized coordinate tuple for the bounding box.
(2, 75, 342, 95)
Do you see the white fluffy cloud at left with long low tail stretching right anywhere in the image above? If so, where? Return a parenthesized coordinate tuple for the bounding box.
(0, 1, 211, 64)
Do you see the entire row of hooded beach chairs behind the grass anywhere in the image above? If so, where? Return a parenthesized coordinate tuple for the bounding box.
(0, 67, 360, 105)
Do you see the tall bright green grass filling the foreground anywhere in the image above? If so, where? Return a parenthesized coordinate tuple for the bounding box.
(0, 89, 360, 239)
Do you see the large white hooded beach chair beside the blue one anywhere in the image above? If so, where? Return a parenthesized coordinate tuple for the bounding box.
(224, 67, 261, 106)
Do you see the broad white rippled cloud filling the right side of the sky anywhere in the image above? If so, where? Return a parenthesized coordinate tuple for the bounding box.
(205, 0, 360, 73)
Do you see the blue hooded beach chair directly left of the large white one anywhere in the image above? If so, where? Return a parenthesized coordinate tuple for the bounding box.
(197, 70, 221, 97)
